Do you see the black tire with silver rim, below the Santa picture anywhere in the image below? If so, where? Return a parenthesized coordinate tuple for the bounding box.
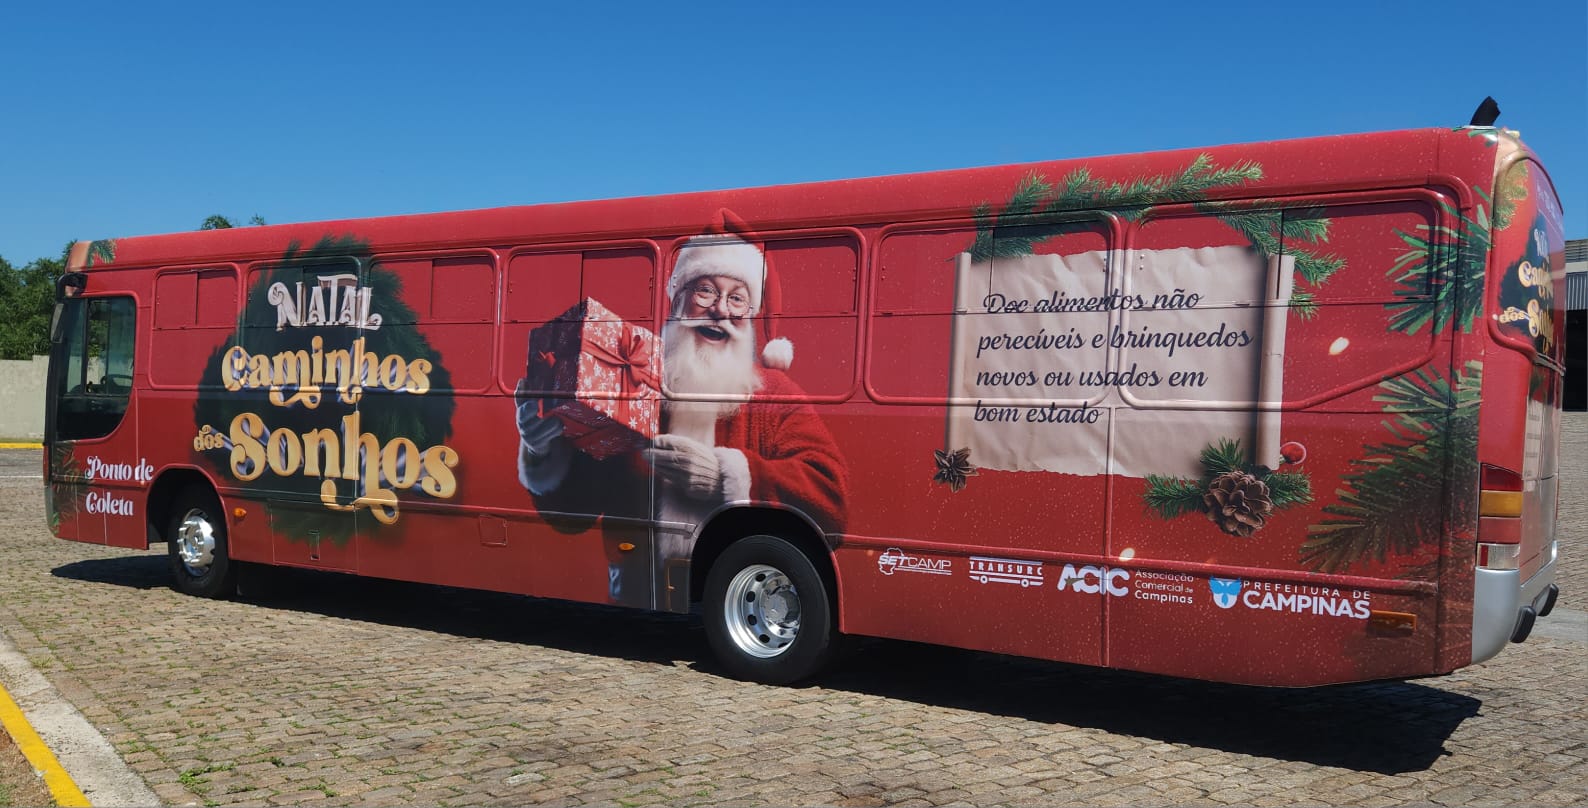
(702, 537, 838, 684)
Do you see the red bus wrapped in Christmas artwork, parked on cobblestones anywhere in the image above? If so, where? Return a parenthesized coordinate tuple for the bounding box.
(44, 125, 1564, 686)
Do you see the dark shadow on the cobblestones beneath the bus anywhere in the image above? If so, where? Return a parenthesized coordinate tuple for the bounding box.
(54, 554, 1482, 775)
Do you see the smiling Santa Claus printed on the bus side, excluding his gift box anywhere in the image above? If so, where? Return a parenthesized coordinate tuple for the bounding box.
(518, 211, 848, 602)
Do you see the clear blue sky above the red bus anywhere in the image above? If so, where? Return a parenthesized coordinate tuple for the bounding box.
(0, 0, 1588, 264)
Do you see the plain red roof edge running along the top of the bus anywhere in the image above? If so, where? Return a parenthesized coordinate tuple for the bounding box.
(71, 127, 1549, 268)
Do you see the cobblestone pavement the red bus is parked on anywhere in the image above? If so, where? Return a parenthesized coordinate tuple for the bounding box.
(0, 414, 1588, 806)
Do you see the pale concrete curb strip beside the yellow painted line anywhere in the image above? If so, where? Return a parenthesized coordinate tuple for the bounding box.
(0, 633, 160, 806)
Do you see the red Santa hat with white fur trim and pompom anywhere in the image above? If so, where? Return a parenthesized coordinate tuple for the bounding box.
(667, 208, 794, 370)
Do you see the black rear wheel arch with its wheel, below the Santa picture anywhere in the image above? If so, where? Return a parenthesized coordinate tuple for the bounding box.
(691, 508, 840, 684)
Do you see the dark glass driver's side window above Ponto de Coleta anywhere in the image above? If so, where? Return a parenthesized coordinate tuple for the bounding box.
(56, 297, 137, 440)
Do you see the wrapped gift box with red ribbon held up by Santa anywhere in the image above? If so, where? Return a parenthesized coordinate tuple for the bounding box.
(524, 298, 662, 460)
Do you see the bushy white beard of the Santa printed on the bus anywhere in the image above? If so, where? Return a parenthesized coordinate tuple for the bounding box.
(662, 319, 761, 432)
